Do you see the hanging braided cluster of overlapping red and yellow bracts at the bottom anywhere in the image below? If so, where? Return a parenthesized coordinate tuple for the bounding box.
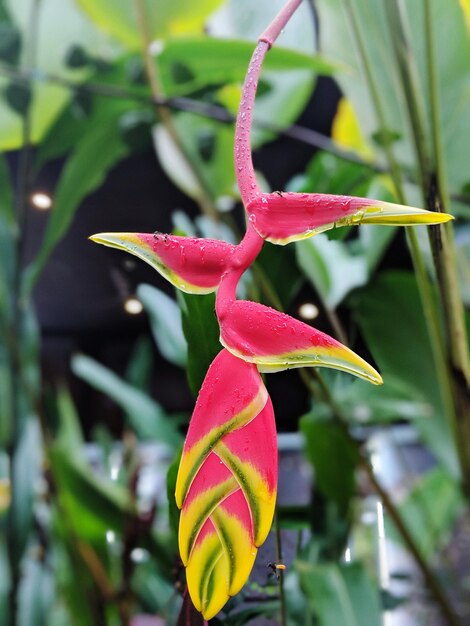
(175, 350, 277, 619)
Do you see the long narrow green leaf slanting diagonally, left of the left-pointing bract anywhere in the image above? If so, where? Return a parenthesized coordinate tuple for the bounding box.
(26, 102, 132, 291)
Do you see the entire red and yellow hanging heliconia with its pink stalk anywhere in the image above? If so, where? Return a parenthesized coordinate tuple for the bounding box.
(91, 0, 451, 619)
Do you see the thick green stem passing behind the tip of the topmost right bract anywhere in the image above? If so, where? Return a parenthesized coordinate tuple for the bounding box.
(385, 2, 470, 500)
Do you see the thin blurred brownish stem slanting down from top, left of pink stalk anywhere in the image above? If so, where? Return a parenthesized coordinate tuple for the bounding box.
(133, 0, 219, 220)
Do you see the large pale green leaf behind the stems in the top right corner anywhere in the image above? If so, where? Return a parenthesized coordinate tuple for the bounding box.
(318, 0, 470, 191)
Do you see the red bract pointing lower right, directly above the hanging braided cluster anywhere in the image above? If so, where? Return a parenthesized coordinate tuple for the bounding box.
(219, 300, 382, 385)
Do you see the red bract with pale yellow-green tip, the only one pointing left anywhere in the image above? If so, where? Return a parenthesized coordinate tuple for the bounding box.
(90, 233, 236, 294)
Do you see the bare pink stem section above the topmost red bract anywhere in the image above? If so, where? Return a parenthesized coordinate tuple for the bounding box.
(235, 0, 302, 206)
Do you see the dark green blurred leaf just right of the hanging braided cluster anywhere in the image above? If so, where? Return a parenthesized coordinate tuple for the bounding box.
(300, 415, 359, 516)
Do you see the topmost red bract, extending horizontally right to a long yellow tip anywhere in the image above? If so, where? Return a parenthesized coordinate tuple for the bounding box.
(246, 192, 453, 245)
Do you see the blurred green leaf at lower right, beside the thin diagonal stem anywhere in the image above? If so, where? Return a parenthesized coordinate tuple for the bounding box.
(387, 467, 464, 561)
